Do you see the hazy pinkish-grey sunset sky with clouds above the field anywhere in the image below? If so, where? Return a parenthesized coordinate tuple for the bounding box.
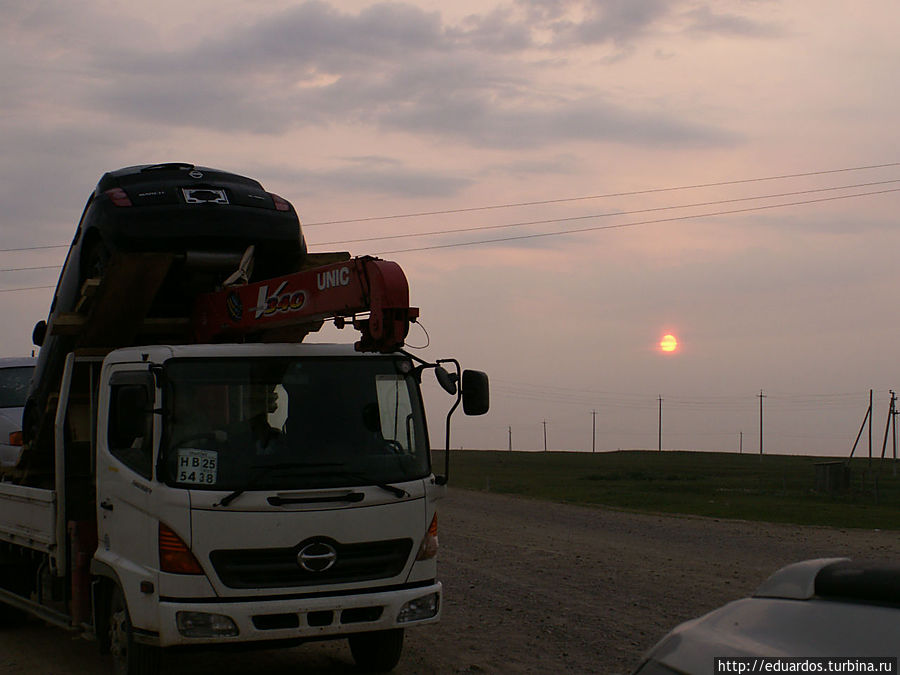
(0, 0, 900, 456)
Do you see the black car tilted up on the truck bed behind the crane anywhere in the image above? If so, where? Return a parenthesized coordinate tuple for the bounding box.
(23, 163, 306, 460)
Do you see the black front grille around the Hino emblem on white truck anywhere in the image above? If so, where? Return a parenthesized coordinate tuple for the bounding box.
(209, 538, 413, 588)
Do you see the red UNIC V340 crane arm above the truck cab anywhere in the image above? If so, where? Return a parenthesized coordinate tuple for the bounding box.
(192, 256, 419, 352)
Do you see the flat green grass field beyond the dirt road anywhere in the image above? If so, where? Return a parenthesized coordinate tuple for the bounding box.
(434, 450, 900, 530)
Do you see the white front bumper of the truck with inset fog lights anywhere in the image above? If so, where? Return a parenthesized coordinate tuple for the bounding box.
(156, 582, 442, 647)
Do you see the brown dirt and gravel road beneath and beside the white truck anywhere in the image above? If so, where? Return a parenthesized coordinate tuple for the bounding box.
(0, 490, 900, 675)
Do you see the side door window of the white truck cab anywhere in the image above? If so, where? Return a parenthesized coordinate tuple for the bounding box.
(106, 373, 153, 479)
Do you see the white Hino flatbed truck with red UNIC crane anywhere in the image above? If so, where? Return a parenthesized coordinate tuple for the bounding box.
(0, 180, 488, 675)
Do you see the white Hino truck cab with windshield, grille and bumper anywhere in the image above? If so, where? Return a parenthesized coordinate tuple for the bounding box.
(94, 345, 444, 632)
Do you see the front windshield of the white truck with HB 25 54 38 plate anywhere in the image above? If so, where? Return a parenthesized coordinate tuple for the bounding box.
(159, 357, 431, 490)
